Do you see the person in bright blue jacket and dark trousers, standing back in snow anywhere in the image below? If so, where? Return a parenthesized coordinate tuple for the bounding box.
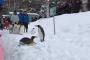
(18, 11, 29, 32)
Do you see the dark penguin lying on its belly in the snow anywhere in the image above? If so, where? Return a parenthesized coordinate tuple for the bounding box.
(19, 36, 36, 46)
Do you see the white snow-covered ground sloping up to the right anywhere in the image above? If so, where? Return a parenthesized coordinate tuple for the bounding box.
(2, 12, 90, 60)
